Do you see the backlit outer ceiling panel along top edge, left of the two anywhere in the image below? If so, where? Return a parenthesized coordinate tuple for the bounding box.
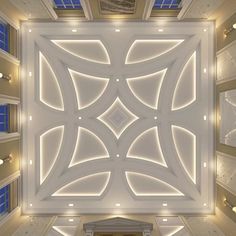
(51, 39, 111, 64)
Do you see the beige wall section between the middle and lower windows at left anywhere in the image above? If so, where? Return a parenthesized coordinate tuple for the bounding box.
(0, 140, 20, 180)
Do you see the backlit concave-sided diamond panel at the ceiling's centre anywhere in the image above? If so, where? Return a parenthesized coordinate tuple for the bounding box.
(98, 98, 138, 139)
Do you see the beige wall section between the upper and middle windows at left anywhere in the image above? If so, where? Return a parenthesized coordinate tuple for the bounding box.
(0, 56, 20, 98)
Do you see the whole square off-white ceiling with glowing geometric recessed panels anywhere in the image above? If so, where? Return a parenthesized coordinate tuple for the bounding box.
(22, 22, 214, 214)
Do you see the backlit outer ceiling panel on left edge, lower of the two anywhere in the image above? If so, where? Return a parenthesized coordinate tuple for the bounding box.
(40, 126, 64, 184)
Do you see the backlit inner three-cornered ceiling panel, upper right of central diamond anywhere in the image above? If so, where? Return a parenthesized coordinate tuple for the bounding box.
(127, 69, 167, 109)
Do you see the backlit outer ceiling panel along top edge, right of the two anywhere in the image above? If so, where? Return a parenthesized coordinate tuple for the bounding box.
(125, 39, 184, 64)
